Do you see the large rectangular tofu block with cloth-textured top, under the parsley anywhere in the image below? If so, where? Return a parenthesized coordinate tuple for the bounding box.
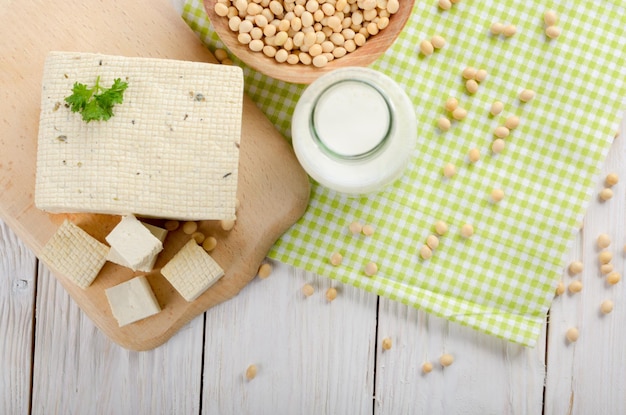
(35, 52, 243, 220)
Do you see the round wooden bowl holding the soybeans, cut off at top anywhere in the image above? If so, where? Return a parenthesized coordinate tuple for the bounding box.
(204, 0, 415, 84)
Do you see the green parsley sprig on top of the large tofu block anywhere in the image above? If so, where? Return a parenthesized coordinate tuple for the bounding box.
(65, 76, 128, 122)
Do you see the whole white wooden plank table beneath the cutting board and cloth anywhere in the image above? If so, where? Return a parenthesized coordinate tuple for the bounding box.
(0, 0, 626, 415)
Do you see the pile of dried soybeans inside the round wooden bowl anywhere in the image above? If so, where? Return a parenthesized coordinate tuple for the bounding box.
(214, 0, 400, 68)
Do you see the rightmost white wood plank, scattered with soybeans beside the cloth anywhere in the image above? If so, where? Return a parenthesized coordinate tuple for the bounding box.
(545, 114, 626, 415)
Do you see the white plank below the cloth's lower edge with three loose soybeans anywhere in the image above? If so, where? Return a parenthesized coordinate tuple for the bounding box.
(376, 298, 545, 414)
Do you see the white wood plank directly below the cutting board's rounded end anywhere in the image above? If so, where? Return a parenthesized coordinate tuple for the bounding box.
(33, 266, 204, 414)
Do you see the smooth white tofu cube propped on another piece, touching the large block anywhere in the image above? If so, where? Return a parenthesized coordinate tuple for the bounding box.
(104, 215, 163, 271)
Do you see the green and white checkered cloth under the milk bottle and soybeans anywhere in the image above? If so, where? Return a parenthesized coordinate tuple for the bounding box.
(183, 0, 626, 345)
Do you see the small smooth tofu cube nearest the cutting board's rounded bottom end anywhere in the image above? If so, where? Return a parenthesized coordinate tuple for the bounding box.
(104, 275, 161, 327)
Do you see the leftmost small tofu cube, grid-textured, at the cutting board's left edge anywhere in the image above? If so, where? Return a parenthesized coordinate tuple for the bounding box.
(39, 220, 109, 289)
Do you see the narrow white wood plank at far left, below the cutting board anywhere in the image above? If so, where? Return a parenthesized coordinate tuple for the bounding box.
(0, 220, 36, 414)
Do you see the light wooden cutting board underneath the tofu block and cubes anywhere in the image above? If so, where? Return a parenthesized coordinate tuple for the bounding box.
(0, 0, 310, 350)
